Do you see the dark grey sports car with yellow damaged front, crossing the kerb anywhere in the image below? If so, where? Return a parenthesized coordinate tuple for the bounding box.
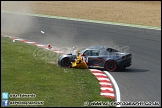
(58, 46, 132, 72)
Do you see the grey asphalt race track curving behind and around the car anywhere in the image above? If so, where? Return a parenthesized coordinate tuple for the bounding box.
(1, 13, 161, 104)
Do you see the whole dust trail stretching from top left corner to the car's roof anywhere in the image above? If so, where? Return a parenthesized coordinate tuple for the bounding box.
(1, 1, 117, 52)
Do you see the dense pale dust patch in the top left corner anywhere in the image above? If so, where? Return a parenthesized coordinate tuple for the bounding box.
(1, 1, 33, 35)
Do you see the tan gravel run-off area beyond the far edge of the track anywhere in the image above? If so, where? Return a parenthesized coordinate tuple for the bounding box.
(1, 1, 161, 28)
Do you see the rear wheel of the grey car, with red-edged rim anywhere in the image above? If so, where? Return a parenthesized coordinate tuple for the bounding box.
(105, 60, 117, 72)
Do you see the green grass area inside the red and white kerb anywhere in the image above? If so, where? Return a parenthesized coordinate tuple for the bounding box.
(1, 37, 113, 107)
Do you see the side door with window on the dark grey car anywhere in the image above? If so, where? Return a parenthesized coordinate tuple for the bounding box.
(84, 50, 103, 66)
